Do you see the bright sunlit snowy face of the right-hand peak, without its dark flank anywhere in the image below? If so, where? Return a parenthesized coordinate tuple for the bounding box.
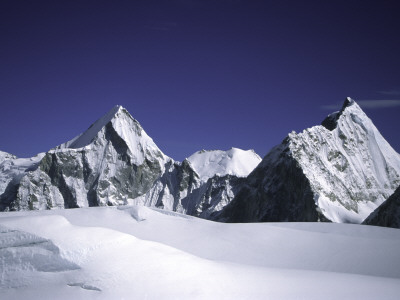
(289, 98, 400, 223)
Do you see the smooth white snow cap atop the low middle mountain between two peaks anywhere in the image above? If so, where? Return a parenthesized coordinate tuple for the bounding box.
(187, 148, 261, 181)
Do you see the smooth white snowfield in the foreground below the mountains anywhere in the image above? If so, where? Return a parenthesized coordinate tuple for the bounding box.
(0, 206, 400, 300)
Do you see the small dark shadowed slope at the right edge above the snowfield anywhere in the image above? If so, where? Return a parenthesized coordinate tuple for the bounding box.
(363, 187, 400, 228)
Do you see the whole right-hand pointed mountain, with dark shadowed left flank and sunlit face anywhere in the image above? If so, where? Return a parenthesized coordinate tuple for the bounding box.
(216, 98, 400, 223)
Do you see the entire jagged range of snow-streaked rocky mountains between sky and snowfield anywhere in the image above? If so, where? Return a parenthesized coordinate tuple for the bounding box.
(0, 97, 400, 227)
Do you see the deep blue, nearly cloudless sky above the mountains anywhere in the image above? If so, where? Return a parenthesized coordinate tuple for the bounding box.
(0, 0, 400, 160)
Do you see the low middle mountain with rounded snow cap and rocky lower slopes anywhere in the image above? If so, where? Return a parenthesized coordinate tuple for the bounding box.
(133, 148, 261, 218)
